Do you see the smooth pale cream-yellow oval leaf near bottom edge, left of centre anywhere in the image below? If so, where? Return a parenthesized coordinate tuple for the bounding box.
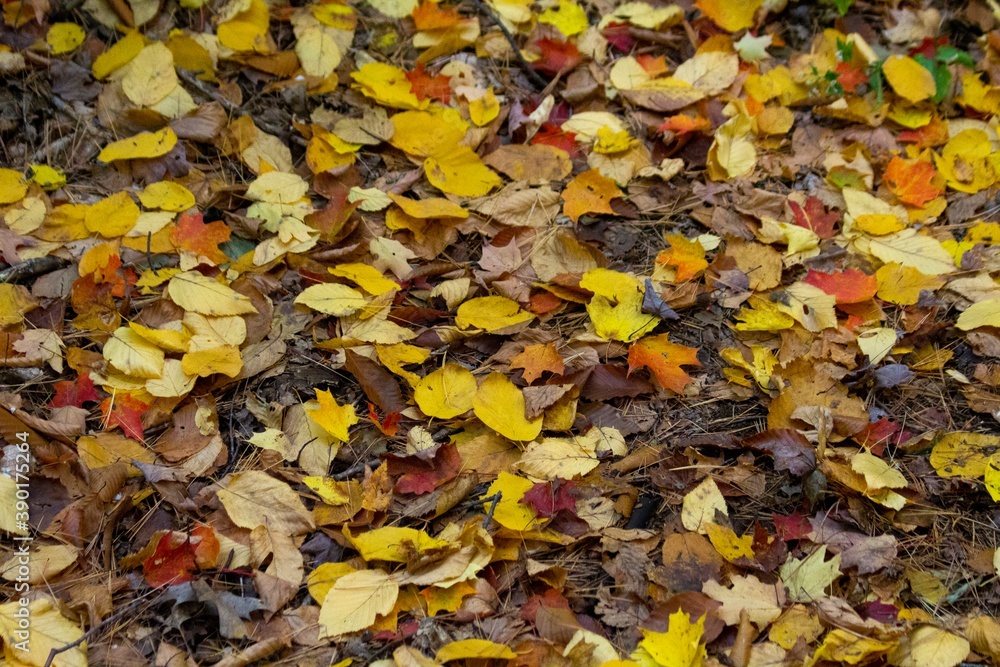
(319, 570, 399, 639)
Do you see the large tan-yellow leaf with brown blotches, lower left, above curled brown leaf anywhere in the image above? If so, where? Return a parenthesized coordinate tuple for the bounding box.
(218, 470, 316, 535)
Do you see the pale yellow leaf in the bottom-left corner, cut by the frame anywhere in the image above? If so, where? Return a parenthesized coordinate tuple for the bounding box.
(0, 597, 87, 667)
